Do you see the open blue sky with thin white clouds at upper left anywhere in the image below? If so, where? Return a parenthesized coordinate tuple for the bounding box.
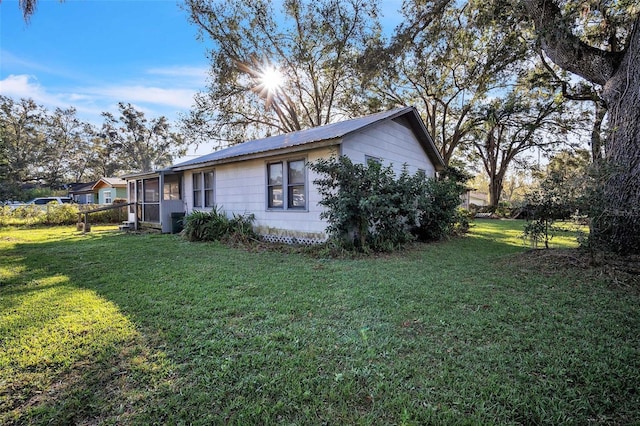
(0, 0, 401, 156)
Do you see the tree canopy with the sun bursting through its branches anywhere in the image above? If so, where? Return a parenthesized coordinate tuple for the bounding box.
(184, 0, 380, 144)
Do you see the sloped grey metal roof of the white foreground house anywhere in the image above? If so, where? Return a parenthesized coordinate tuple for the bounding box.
(172, 107, 442, 169)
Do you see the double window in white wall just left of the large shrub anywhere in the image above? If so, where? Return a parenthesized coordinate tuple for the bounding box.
(267, 160, 307, 210)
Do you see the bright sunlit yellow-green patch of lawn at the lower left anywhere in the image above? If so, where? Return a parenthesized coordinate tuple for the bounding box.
(0, 231, 175, 425)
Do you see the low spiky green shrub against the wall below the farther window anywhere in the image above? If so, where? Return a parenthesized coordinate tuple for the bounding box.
(182, 207, 257, 241)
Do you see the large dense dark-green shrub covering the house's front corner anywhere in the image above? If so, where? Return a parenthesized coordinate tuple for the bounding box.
(309, 156, 468, 252)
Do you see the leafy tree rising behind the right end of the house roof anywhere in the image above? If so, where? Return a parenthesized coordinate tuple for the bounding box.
(361, 0, 530, 164)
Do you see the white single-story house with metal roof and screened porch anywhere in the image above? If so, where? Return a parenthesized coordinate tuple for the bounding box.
(124, 107, 444, 242)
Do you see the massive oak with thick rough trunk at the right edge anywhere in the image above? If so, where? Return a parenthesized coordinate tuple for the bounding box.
(523, 0, 640, 254)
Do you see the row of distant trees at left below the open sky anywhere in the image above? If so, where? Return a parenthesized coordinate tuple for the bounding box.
(0, 95, 187, 199)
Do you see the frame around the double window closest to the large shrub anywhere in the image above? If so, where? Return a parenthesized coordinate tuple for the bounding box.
(265, 157, 309, 212)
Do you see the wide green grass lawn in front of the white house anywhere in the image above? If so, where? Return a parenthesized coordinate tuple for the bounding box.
(0, 221, 640, 425)
